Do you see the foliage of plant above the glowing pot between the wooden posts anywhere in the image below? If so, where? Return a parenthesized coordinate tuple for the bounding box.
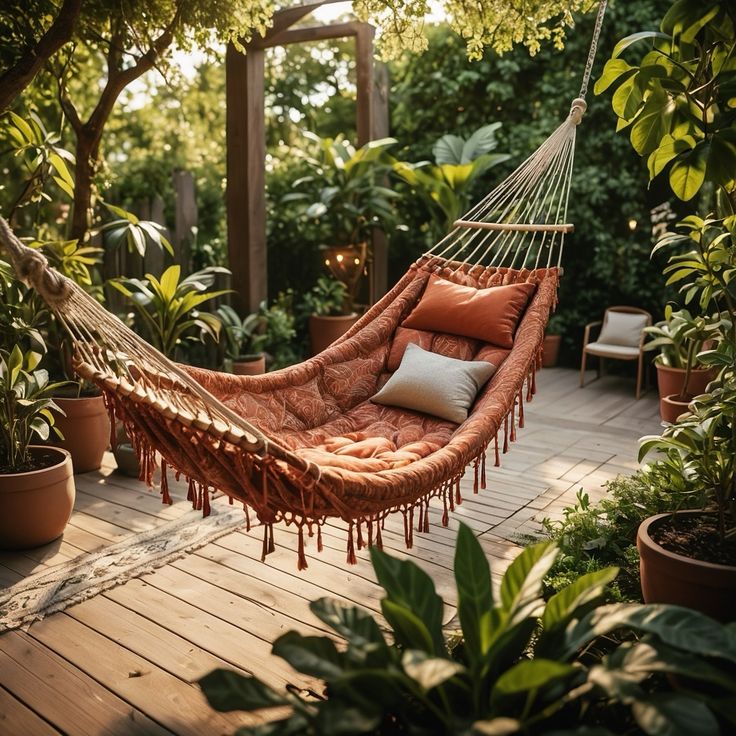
(282, 137, 399, 252)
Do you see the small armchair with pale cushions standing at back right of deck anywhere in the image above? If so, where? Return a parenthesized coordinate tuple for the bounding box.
(580, 307, 652, 399)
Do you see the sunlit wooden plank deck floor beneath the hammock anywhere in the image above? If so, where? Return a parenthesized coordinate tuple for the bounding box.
(0, 369, 660, 736)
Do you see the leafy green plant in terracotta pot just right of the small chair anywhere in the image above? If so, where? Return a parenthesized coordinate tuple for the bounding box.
(644, 305, 721, 422)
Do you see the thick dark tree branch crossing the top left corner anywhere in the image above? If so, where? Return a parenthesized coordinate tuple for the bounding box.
(0, 0, 82, 112)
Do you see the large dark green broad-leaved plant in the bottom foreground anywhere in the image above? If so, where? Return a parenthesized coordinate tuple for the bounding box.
(200, 525, 736, 736)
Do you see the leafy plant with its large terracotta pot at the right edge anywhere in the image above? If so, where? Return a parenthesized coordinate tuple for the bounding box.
(637, 386, 736, 621)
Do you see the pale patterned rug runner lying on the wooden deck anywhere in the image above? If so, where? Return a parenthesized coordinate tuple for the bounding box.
(0, 506, 245, 633)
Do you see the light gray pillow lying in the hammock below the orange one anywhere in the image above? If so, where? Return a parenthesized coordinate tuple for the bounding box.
(371, 343, 496, 424)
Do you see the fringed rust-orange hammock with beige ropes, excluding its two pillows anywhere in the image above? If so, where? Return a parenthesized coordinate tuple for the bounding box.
(0, 0, 605, 569)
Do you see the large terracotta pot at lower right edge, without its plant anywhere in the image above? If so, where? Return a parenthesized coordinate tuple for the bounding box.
(636, 511, 736, 622)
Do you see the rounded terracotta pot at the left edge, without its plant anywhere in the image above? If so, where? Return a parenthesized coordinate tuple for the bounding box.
(0, 447, 75, 549)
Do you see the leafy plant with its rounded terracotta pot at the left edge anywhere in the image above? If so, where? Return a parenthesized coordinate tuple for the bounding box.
(0, 344, 75, 549)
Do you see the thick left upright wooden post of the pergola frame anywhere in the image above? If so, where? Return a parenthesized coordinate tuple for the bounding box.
(225, 44, 268, 314)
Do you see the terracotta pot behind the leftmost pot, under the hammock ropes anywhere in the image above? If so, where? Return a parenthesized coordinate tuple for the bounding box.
(52, 396, 110, 473)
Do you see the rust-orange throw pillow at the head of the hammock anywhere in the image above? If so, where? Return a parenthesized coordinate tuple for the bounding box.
(402, 276, 536, 348)
